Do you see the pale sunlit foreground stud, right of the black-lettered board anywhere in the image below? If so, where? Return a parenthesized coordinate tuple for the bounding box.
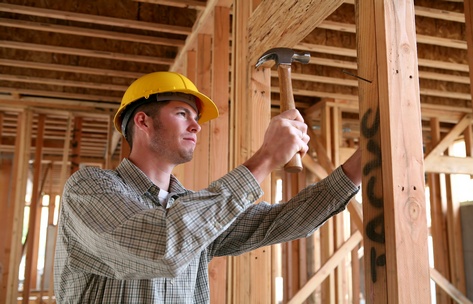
(374, 0, 430, 303)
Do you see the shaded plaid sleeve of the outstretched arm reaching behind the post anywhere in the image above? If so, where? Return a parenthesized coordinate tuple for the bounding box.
(210, 167, 359, 256)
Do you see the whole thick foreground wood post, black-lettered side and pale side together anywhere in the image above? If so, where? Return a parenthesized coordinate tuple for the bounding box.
(356, 0, 430, 303)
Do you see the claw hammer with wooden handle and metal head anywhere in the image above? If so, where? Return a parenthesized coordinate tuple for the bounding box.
(256, 48, 310, 173)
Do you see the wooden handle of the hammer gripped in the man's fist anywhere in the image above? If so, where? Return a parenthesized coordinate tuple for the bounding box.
(278, 64, 302, 173)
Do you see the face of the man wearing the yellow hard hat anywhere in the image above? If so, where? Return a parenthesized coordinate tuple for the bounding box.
(150, 101, 201, 165)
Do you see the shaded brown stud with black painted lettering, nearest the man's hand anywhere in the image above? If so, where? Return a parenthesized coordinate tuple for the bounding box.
(355, 0, 388, 303)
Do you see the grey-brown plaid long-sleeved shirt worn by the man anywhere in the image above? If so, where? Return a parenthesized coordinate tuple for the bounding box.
(54, 159, 358, 303)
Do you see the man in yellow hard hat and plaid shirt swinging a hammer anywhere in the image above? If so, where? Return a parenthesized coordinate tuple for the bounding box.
(55, 72, 361, 303)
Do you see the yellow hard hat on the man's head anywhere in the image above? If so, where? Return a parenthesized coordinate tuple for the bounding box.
(113, 72, 218, 135)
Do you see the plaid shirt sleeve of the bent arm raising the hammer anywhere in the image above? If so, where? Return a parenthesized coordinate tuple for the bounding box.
(59, 168, 262, 279)
